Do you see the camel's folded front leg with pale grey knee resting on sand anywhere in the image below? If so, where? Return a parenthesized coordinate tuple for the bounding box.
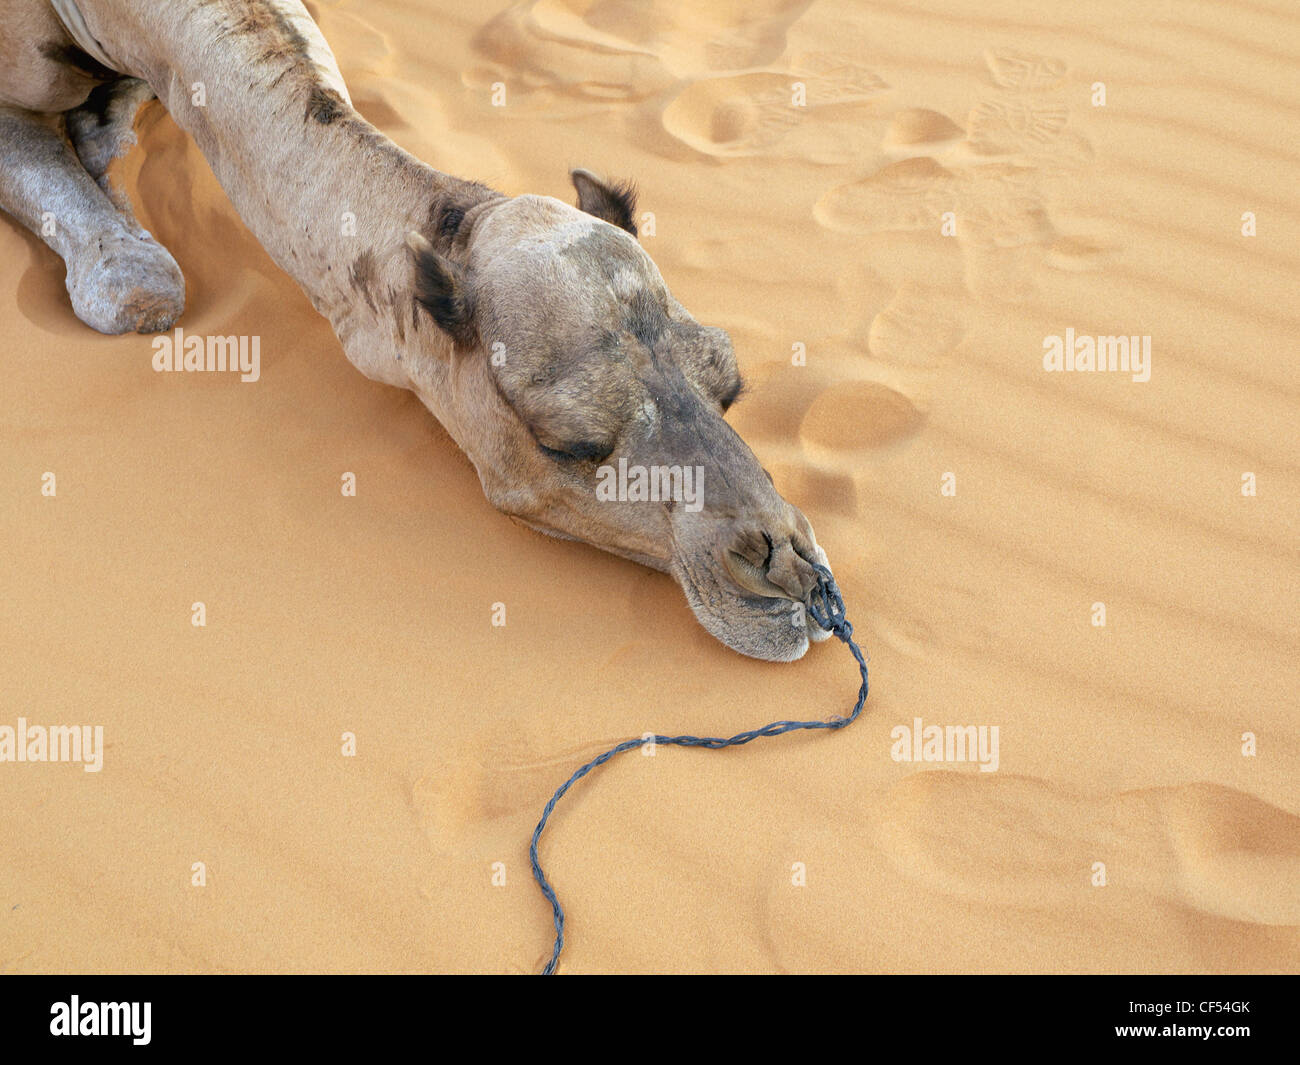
(0, 99, 185, 333)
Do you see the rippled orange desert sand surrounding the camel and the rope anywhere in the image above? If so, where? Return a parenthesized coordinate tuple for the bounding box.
(0, 0, 1300, 973)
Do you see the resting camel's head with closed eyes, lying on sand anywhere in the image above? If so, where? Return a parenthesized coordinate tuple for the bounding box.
(408, 170, 827, 662)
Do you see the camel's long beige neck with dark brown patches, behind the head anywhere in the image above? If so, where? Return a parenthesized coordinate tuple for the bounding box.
(78, 0, 498, 384)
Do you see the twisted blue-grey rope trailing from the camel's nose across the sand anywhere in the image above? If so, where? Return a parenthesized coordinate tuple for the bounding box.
(528, 564, 867, 977)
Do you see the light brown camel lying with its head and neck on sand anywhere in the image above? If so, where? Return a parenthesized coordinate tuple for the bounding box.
(0, 0, 828, 662)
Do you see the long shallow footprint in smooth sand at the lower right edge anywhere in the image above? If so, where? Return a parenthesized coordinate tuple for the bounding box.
(874, 770, 1300, 925)
